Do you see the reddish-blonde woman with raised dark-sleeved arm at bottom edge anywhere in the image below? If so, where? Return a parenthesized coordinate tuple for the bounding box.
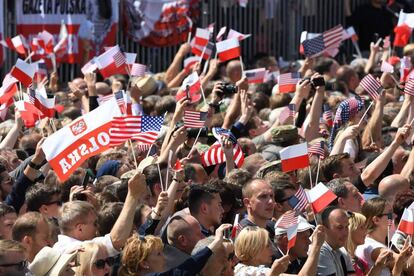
(118, 224, 231, 276)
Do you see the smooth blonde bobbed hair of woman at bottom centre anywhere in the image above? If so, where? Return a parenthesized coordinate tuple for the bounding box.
(234, 226, 269, 262)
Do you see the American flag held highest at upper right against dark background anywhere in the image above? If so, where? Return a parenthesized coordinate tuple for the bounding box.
(302, 25, 343, 57)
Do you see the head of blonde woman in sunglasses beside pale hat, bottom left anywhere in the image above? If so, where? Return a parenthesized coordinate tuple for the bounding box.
(75, 242, 115, 276)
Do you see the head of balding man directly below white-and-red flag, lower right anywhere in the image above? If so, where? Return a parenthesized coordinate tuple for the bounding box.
(320, 206, 349, 250)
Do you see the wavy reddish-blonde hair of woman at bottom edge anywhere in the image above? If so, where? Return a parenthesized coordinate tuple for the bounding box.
(118, 233, 164, 276)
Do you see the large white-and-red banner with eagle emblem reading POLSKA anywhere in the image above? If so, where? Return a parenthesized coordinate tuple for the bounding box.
(42, 98, 121, 182)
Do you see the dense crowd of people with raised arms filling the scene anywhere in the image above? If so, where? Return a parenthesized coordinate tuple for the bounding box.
(4, 1, 414, 276)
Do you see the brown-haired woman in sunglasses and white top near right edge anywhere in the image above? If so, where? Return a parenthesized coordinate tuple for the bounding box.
(355, 197, 406, 276)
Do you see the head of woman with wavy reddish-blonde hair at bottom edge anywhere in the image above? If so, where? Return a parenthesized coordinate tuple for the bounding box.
(118, 234, 165, 276)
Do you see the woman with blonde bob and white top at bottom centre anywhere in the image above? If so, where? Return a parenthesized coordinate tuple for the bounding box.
(234, 226, 289, 276)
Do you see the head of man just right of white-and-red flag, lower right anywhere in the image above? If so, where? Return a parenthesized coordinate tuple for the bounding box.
(326, 178, 363, 212)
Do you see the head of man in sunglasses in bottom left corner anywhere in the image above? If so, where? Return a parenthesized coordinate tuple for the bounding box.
(0, 240, 29, 276)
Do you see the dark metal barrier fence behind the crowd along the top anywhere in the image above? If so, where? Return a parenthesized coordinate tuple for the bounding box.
(2, 0, 369, 81)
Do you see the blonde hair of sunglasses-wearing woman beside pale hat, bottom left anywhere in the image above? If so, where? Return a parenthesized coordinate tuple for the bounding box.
(75, 242, 106, 276)
